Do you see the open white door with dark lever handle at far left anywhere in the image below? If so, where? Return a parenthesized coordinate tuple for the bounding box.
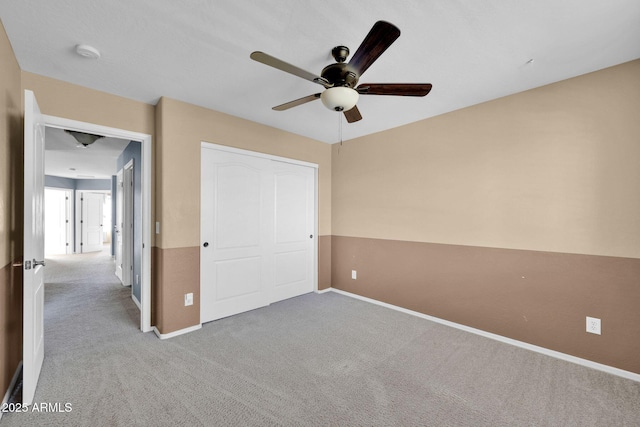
(22, 90, 44, 405)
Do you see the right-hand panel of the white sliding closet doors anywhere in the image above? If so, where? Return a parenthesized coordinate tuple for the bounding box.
(271, 161, 316, 302)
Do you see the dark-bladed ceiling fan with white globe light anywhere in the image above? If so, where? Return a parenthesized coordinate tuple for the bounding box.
(250, 21, 431, 123)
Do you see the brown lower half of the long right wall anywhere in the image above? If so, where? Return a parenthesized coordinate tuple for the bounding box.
(331, 236, 640, 374)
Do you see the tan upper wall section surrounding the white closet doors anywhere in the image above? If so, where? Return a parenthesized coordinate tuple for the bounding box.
(156, 98, 331, 249)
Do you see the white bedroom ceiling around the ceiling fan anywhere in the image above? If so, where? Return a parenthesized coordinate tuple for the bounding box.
(0, 0, 640, 143)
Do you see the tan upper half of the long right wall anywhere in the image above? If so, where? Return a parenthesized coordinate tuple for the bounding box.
(332, 60, 640, 258)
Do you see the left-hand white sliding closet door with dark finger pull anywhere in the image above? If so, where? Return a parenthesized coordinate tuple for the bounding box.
(200, 149, 273, 323)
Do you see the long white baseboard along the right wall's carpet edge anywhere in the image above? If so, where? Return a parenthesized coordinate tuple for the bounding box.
(330, 288, 640, 382)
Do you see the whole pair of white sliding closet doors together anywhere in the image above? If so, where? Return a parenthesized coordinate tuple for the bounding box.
(200, 143, 317, 323)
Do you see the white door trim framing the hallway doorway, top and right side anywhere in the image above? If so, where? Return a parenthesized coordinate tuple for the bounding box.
(43, 114, 152, 332)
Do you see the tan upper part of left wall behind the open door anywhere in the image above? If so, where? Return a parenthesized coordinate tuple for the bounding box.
(0, 23, 22, 268)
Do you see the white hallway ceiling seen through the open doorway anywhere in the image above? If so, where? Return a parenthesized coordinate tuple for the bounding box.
(44, 127, 130, 179)
